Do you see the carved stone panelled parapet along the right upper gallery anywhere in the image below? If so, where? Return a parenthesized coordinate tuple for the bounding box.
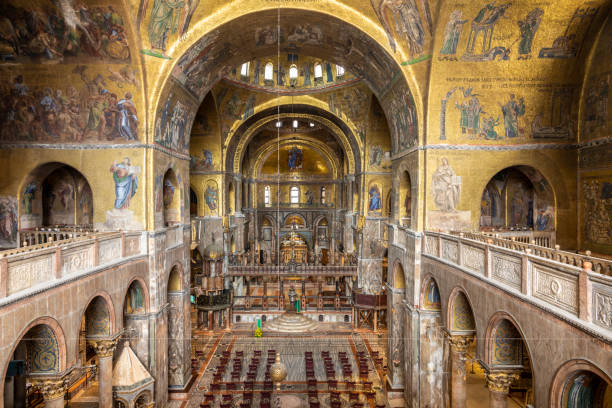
(422, 232, 612, 338)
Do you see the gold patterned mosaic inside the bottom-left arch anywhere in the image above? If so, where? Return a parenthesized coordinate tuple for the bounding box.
(21, 324, 60, 373)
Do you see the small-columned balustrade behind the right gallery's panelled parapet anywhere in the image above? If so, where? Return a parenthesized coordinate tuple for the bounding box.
(460, 232, 612, 276)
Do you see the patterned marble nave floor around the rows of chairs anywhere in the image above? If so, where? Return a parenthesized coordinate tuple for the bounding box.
(168, 330, 386, 408)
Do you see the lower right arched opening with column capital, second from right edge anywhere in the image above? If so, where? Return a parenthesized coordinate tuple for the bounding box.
(486, 314, 535, 406)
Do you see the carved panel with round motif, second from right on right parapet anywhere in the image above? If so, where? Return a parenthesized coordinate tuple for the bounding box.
(532, 265, 578, 313)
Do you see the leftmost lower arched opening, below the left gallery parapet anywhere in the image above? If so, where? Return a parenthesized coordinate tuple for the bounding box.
(4, 322, 64, 408)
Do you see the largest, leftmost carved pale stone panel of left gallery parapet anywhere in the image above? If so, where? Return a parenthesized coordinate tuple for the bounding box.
(7, 254, 53, 295)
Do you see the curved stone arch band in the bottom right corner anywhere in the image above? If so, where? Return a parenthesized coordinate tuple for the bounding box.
(549, 359, 612, 408)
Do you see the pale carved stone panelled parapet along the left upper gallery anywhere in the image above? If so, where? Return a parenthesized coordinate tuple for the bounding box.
(0, 232, 146, 299)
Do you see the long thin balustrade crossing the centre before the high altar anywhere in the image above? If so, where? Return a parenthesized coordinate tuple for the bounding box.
(228, 265, 357, 277)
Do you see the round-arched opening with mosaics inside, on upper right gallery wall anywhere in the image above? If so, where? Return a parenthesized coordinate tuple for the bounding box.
(480, 166, 556, 246)
